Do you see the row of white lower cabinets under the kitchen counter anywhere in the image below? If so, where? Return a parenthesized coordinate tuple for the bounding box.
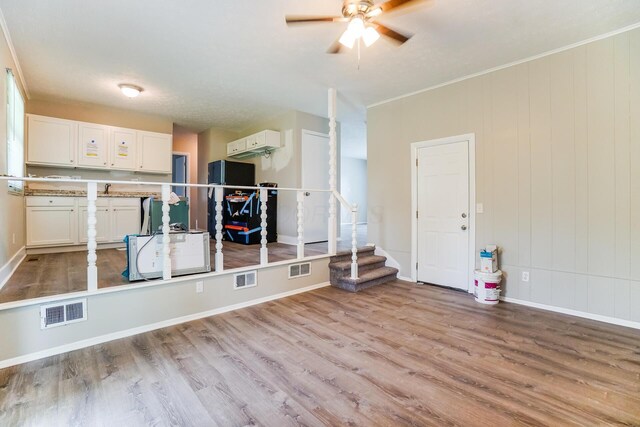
(25, 196, 141, 247)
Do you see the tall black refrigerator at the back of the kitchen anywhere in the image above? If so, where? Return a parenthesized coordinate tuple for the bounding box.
(207, 160, 256, 234)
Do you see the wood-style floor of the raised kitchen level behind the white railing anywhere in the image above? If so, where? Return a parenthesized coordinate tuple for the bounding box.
(0, 225, 366, 303)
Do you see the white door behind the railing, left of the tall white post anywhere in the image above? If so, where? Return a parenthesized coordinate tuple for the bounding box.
(302, 130, 329, 243)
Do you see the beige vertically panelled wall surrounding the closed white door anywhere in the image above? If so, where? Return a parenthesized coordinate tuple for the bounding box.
(367, 29, 640, 321)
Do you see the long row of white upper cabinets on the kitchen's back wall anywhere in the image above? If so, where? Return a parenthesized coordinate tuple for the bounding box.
(27, 114, 173, 174)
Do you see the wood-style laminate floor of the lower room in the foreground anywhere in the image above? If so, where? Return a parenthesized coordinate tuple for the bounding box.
(0, 281, 640, 427)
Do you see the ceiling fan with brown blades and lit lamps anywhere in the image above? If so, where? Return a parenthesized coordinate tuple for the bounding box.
(285, 0, 422, 53)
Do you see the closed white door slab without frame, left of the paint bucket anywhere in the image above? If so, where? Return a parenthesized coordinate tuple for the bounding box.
(417, 141, 470, 290)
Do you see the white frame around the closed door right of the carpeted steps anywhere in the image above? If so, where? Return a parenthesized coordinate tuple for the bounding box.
(411, 133, 476, 293)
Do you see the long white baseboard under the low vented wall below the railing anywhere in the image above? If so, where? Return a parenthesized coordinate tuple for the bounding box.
(0, 282, 330, 369)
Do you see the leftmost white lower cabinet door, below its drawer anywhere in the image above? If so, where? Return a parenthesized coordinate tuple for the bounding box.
(27, 206, 78, 246)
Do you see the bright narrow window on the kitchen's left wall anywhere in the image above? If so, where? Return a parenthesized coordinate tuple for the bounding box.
(7, 69, 24, 193)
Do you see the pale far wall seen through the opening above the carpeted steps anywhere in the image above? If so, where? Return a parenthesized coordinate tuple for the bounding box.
(340, 156, 367, 224)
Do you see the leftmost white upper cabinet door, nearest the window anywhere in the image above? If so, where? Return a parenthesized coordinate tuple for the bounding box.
(27, 115, 78, 167)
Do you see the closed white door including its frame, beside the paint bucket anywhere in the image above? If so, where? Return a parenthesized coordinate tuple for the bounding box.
(411, 134, 476, 292)
